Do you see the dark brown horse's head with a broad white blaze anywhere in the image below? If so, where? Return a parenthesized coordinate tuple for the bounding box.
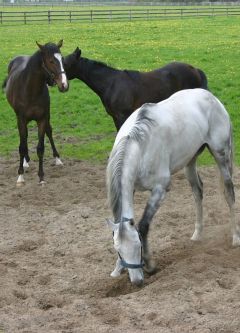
(36, 40, 68, 92)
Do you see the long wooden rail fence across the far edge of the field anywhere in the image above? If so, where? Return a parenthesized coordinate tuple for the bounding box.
(0, 6, 240, 24)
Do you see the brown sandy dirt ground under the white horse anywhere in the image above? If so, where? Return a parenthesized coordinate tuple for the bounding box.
(0, 158, 240, 333)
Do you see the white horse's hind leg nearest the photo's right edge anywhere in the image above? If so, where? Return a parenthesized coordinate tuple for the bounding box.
(209, 145, 240, 246)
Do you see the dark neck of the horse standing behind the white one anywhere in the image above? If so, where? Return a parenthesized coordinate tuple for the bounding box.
(77, 58, 119, 97)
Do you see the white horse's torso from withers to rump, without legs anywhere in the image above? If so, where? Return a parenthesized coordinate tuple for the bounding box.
(115, 89, 231, 174)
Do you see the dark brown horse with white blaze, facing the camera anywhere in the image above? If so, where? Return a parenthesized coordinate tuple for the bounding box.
(2, 40, 68, 185)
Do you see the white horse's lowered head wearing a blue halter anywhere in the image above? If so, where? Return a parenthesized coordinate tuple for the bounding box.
(107, 218, 144, 286)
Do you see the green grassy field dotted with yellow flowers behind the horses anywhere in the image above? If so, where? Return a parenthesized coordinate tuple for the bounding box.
(0, 17, 240, 164)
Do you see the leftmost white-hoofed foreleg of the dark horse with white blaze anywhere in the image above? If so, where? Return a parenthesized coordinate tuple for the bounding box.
(17, 118, 28, 186)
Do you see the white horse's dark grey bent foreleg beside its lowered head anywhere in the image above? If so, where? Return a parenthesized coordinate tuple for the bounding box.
(139, 185, 167, 273)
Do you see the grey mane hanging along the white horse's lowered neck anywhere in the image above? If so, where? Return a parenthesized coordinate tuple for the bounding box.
(106, 137, 128, 222)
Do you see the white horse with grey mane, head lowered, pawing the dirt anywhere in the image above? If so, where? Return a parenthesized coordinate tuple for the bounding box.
(107, 89, 240, 284)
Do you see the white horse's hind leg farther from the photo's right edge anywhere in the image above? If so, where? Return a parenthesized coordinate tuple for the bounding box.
(185, 157, 203, 241)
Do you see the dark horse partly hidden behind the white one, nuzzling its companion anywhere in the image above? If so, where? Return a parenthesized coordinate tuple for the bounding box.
(64, 48, 207, 130)
